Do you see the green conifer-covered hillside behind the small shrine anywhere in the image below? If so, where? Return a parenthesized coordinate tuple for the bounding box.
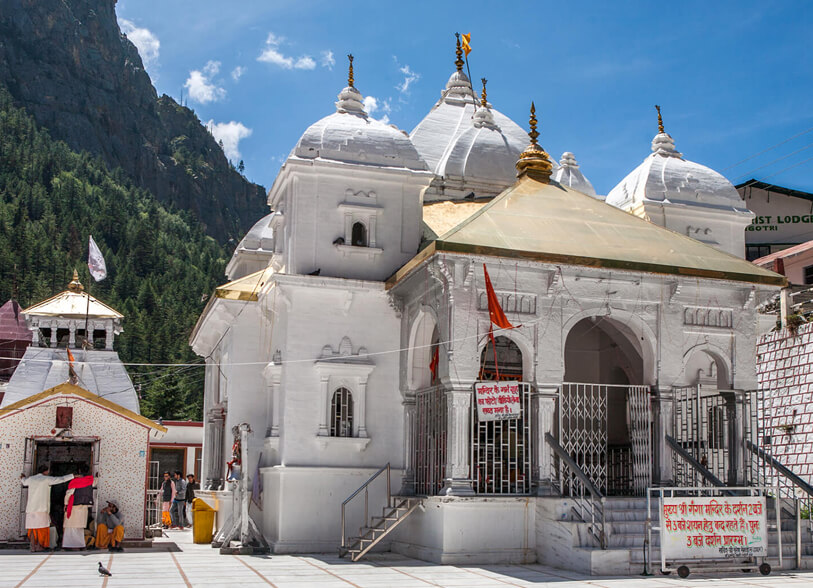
(0, 88, 222, 419)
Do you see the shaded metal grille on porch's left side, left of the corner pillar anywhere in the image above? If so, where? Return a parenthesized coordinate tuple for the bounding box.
(415, 387, 447, 496)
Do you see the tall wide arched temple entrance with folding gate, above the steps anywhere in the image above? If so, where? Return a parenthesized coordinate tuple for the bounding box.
(558, 316, 652, 495)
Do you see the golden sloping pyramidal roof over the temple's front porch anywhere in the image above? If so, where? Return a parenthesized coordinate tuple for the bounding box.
(394, 176, 787, 287)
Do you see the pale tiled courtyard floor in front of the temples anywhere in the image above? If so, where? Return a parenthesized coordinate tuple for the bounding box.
(0, 531, 813, 588)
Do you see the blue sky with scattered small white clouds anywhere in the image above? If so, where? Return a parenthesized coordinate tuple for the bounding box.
(117, 0, 813, 194)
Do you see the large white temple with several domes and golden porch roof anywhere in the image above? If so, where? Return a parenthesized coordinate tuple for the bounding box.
(191, 44, 784, 573)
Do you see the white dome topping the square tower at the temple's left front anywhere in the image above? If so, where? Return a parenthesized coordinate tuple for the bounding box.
(291, 86, 427, 170)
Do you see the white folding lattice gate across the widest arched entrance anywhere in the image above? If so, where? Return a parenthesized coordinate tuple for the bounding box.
(559, 383, 652, 495)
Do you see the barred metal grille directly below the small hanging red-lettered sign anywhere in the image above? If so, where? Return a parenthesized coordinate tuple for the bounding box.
(470, 382, 533, 494)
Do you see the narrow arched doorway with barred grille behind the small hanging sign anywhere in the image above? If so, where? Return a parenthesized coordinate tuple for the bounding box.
(471, 337, 533, 494)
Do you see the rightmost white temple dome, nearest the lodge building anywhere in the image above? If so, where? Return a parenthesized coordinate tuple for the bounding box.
(606, 132, 746, 210)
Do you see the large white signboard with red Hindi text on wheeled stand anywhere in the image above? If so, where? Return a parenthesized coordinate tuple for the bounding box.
(661, 496, 768, 561)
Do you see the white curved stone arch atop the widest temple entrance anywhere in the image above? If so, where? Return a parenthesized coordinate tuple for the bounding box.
(562, 307, 658, 386)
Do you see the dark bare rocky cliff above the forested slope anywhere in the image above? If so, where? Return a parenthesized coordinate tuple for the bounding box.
(0, 0, 267, 243)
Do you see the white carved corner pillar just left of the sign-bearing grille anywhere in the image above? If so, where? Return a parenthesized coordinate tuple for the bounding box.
(440, 387, 474, 496)
